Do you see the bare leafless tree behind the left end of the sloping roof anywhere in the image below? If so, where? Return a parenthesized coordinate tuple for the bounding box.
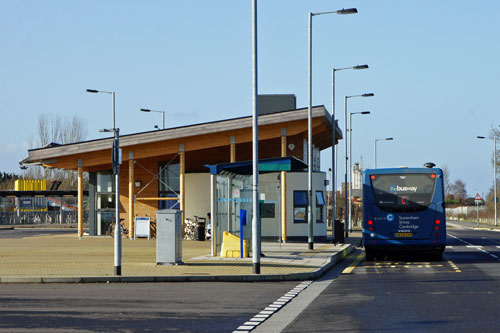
(25, 114, 88, 189)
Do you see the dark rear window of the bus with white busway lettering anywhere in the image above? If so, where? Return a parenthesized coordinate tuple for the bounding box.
(370, 173, 436, 211)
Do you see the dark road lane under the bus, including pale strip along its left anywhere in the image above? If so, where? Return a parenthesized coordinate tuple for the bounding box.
(255, 229, 500, 332)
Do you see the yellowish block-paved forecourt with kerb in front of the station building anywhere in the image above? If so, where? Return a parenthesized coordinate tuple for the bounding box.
(0, 230, 361, 283)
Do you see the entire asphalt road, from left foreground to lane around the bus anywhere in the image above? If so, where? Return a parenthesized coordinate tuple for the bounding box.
(0, 224, 500, 332)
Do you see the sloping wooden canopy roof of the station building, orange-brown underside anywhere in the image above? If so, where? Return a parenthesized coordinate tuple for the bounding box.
(20, 106, 342, 171)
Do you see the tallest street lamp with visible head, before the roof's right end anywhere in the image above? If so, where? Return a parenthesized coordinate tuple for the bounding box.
(307, 8, 358, 250)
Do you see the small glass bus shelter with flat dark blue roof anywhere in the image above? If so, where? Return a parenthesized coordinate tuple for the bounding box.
(206, 157, 307, 256)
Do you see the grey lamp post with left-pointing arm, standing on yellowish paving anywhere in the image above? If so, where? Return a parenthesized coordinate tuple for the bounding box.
(87, 89, 122, 275)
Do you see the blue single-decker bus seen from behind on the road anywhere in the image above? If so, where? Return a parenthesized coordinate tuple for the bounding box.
(363, 163, 446, 260)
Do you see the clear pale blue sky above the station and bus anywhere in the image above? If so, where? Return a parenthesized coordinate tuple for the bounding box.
(0, 0, 500, 195)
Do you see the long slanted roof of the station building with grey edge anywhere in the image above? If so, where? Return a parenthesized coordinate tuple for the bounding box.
(24, 106, 342, 169)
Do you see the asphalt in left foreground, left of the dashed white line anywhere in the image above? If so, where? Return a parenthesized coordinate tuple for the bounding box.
(0, 282, 298, 332)
